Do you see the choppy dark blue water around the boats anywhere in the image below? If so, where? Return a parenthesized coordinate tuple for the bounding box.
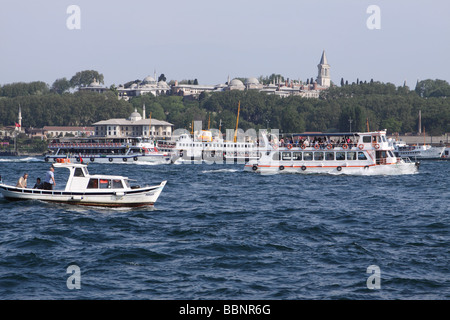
(0, 158, 450, 300)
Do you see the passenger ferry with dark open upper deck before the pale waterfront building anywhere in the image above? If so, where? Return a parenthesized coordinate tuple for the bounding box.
(44, 137, 170, 164)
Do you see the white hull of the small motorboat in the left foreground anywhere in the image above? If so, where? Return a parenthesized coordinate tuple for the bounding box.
(0, 181, 166, 207)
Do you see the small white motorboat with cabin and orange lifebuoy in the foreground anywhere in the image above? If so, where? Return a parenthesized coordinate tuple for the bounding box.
(0, 159, 166, 207)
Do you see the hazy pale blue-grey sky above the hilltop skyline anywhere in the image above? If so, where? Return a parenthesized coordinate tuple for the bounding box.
(0, 0, 450, 86)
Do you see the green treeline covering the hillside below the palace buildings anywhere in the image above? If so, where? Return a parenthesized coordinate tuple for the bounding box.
(0, 79, 450, 135)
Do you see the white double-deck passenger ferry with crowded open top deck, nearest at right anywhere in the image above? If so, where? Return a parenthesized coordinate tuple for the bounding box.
(244, 130, 420, 174)
